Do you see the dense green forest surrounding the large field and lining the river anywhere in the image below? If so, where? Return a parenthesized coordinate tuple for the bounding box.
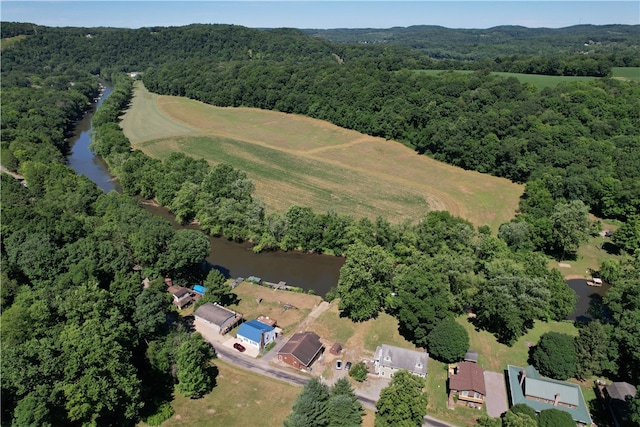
(0, 23, 640, 425)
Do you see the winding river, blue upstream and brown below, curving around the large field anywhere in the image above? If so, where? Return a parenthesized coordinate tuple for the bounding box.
(67, 87, 344, 296)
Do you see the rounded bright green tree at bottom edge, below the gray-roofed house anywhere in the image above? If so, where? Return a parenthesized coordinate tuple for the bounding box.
(375, 370, 427, 427)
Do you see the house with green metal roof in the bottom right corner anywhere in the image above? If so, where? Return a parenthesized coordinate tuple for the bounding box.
(507, 365, 592, 426)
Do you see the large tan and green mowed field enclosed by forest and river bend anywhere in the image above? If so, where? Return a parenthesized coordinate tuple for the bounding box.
(122, 83, 523, 231)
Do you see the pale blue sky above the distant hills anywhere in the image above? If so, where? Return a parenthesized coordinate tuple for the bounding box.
(0, 0, 640, 28)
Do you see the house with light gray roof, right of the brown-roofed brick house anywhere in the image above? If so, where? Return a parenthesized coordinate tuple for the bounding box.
(373, 344, 429, 378)
